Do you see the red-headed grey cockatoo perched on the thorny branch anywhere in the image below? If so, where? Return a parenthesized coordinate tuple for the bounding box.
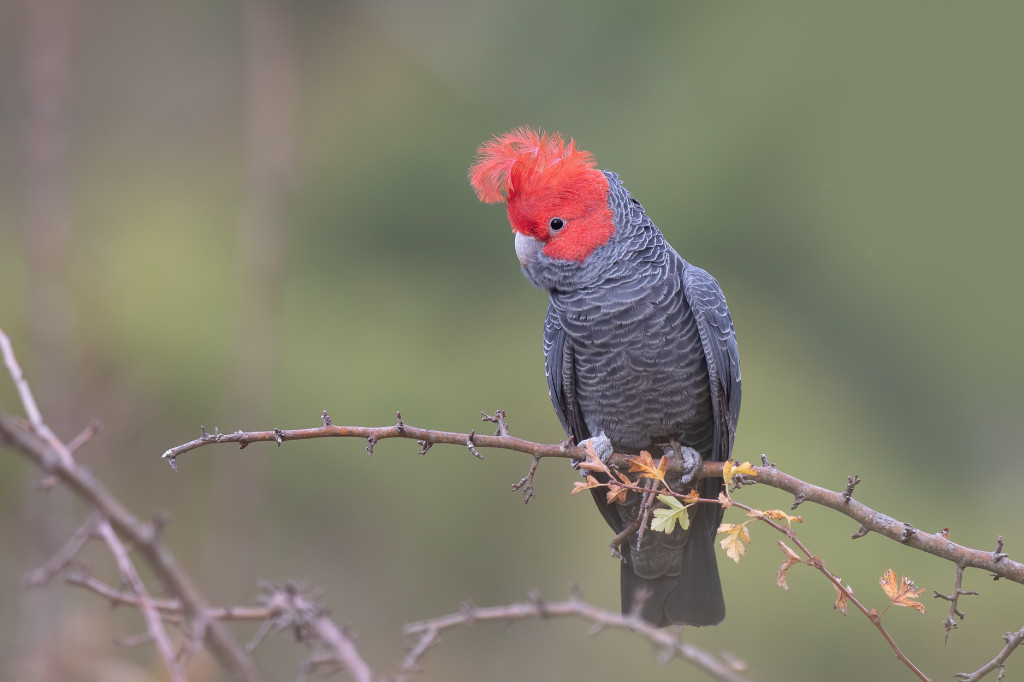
(469, 127, 740, 626)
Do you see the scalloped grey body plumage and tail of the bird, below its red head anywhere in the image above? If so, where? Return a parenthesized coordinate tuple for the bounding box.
(523, 171, 740, 626)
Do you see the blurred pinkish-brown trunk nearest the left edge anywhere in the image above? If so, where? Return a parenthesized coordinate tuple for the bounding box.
(13, 0, 78, 680)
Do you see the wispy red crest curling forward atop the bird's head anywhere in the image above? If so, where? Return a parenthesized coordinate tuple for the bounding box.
(469, 126, 596, 204)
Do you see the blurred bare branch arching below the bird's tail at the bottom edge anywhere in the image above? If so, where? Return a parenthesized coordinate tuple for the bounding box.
(393, 592, 750, 682)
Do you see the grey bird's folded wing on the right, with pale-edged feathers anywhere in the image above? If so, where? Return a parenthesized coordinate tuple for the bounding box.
(683, 263, 742, 462)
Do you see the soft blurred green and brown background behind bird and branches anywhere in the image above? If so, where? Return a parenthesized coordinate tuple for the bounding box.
(0, 0, 1024, 681)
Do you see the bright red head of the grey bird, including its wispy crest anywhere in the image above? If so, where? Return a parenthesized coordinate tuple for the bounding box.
(469, 127, 615, 262)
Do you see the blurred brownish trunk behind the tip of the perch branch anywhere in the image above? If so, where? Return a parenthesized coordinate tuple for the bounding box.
(204, 0, 295, 592)
